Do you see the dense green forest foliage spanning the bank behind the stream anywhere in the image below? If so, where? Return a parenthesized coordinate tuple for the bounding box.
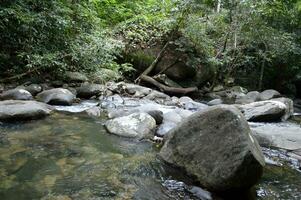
(0, 0, 301, 93)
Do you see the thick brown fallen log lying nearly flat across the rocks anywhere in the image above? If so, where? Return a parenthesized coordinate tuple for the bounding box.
(140, 75, 198, 95)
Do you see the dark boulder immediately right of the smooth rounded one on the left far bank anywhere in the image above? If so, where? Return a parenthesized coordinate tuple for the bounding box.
(76, 84, 105, 99)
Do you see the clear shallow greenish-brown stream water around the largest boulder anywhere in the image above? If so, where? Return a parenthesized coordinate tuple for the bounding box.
(0, 110, 301, 200)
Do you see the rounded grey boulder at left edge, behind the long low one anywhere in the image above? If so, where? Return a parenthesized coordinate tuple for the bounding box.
(0, 88, 33, 100)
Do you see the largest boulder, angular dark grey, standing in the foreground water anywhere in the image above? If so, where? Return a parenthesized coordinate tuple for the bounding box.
(159, 105, 265, 192)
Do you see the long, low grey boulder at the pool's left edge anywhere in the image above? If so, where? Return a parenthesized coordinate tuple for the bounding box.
(0, 100, 51, 121)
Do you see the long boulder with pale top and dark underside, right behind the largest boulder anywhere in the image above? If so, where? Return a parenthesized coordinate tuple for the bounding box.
(237, 100, 287, 122)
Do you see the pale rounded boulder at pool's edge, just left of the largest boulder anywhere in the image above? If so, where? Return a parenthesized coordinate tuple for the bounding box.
(105, 113, 156, 139)
